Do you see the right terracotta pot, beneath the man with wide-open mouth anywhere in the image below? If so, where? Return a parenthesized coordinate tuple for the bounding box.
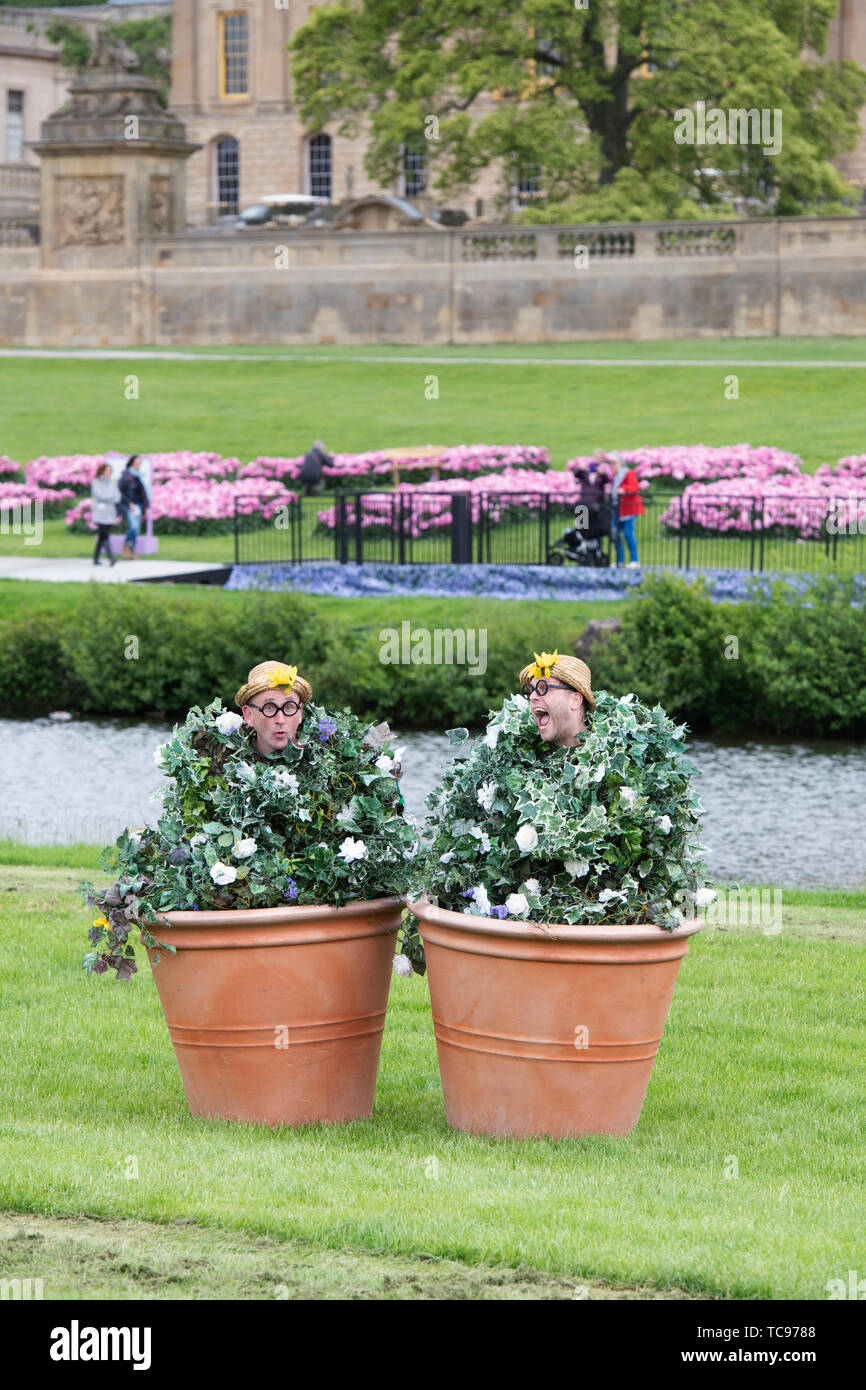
(410, 901, 701, 1138)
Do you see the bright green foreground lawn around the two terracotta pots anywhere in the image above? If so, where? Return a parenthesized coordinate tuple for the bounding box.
(0, 865, 866, 1298)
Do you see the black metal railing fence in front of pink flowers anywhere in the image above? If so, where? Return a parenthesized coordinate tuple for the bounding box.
(235, 489, 866, 571)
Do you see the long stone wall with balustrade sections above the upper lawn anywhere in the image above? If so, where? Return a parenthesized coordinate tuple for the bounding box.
(0, 218, 866, 346)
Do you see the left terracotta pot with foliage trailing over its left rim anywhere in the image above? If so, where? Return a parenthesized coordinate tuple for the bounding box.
(149, 898, 402, 1125)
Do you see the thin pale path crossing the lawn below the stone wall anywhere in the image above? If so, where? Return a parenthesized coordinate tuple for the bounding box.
(0, 348, 866, 371)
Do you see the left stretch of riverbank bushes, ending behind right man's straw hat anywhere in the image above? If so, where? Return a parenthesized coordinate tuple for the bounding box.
(0, 585, 582, 728)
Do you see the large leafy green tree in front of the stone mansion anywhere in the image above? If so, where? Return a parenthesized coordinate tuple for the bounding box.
(291, 0, 866, 220)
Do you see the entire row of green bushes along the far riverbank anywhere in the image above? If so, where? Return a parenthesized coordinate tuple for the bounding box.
(0, 575, 866, 737)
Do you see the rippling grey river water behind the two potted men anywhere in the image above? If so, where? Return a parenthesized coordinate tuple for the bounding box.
(0, 719, 866, 888)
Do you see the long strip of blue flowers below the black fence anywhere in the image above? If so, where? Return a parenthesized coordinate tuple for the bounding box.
(225, 564, 866, 603)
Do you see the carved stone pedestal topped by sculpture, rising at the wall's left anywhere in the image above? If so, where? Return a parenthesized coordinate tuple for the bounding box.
(33, 29, 200, 270)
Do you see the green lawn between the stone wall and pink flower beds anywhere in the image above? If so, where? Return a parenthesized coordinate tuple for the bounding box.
(0, 338, 866, 468)
